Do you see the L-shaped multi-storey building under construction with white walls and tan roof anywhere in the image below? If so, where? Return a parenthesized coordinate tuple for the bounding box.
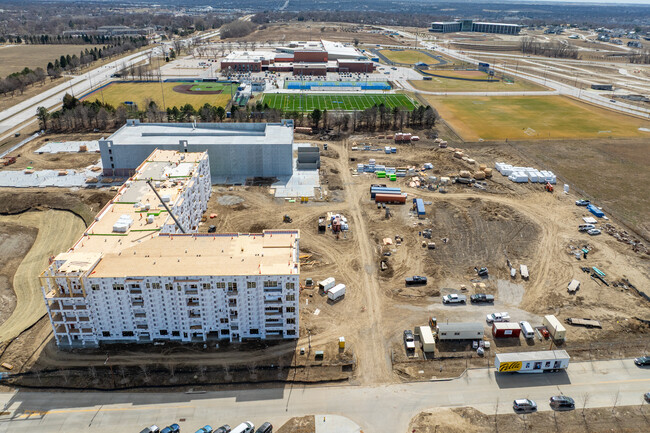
(40, 150, 300, 347)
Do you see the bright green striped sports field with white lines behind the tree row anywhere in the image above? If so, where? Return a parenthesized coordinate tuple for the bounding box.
(262, 93, 417, 112)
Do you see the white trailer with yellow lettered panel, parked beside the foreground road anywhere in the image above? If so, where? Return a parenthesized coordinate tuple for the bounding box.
(494, 350, 571, 373)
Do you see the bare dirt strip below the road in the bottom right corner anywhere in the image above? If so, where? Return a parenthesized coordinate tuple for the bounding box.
(408, 405, 650, 433)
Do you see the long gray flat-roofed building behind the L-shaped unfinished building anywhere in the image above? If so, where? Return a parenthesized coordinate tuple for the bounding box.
(99, 120, 293, 183)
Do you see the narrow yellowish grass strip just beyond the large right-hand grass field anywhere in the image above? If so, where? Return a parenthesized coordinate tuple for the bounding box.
(409, 74, 548, 92)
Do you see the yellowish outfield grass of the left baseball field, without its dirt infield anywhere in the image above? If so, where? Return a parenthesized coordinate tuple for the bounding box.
(84, 83, 234, 110)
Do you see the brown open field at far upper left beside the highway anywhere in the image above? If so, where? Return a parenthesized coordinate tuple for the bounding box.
(0, 45, 101, 78)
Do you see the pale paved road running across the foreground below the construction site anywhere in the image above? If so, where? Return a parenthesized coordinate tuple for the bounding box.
(0, 359, 650, 433)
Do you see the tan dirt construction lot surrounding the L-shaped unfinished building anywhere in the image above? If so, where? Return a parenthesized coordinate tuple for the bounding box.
(0, 130, 650, 387)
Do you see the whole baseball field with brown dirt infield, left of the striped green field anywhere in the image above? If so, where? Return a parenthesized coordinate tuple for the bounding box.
(83, 83, 236, 110)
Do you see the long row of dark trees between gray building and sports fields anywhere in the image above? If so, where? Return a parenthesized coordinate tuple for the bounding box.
(37, 94, 438, 133)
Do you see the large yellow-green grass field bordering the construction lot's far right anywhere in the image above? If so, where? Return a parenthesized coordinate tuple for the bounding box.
(423, 95, 650, 141)
